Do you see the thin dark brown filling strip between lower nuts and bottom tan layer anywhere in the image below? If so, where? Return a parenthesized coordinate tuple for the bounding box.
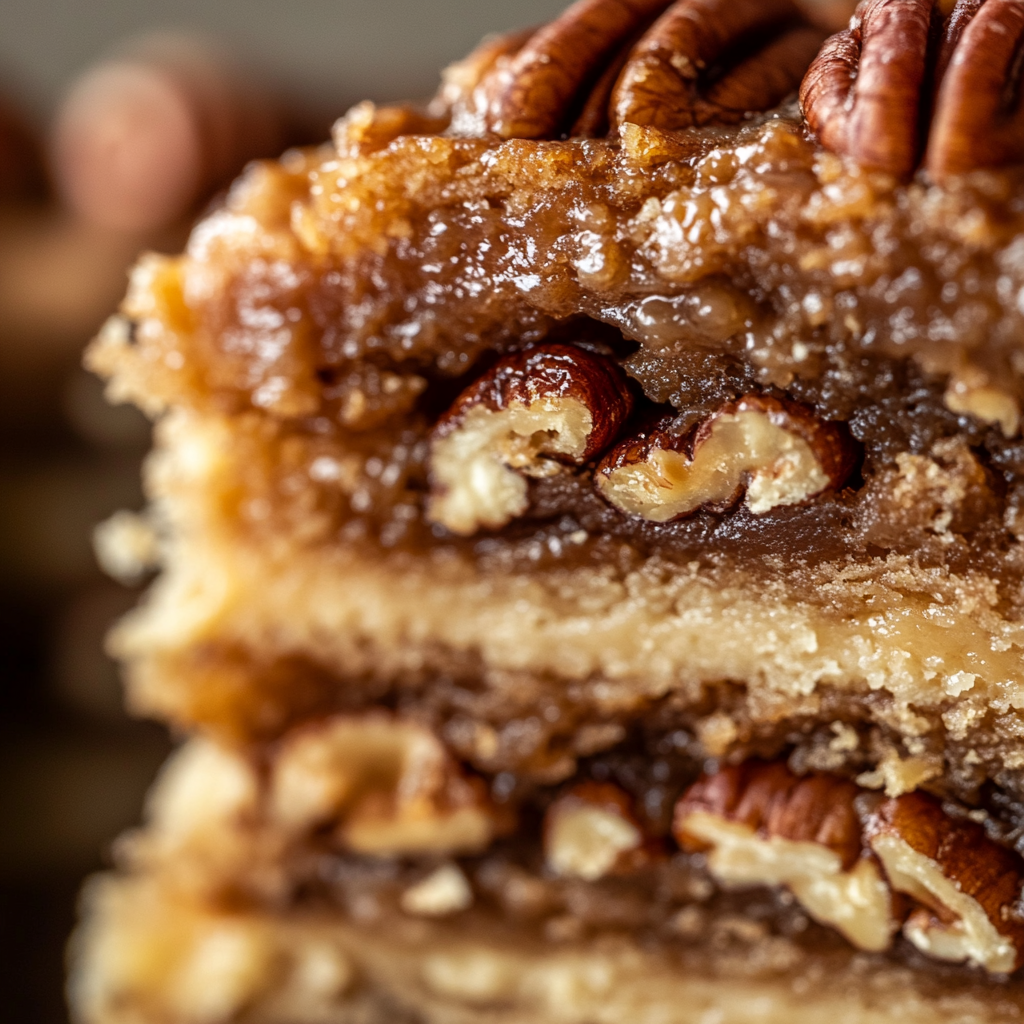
(280, 849, 1005, 993)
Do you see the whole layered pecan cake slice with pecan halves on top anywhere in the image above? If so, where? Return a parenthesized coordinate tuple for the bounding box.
(72, 0, 1024, 1024)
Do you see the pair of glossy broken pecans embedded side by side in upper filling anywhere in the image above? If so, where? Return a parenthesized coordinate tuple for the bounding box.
(427, 345, 858, 535)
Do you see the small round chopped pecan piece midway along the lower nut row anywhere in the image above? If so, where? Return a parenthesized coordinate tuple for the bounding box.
(544, 782, 645, 882)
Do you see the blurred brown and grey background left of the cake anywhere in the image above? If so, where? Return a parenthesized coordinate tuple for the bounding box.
(0, 0, 563, 1024)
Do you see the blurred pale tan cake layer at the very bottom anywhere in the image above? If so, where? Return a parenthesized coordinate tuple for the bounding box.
(71, 878, 1024, 1024)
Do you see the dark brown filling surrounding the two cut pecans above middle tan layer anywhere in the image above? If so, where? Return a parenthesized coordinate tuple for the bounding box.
(134, 335, 1024, 589)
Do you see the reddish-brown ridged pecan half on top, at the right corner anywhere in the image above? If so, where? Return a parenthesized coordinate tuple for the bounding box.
(800, 0, 1024, 182)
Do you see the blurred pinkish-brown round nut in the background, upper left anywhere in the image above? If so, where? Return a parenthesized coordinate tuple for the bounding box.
(50, 32, 311, 231)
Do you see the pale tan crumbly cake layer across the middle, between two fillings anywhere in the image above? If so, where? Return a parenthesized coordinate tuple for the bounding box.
(108, 414, 1024, 769)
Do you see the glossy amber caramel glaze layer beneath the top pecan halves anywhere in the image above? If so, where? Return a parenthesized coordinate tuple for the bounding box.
(108, 110, 1024, 417)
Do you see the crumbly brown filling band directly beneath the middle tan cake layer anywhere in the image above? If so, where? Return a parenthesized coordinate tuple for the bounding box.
(130, 646, 1024, 819)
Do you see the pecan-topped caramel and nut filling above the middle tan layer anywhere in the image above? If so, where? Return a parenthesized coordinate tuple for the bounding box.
(83, 0, 1024, 577)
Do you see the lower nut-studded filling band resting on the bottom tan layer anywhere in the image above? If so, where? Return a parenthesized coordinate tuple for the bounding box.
(142, 712, 1024, 976)
